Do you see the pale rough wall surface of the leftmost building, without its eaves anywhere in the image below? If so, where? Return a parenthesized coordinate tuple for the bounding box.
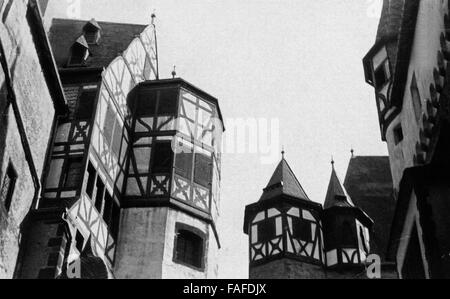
(0, 0, 55, 278)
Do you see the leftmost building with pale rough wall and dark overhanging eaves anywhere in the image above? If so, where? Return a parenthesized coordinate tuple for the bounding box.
(0, 0, 67, 278)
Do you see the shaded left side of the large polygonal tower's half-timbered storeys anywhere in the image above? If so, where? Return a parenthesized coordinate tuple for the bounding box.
(126, 88, 178, 198)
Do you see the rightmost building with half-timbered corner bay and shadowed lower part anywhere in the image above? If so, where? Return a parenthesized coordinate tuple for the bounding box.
(363, 0, 450, 279)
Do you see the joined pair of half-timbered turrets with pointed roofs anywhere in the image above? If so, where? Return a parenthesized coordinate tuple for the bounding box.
(244, 157, 373, 279)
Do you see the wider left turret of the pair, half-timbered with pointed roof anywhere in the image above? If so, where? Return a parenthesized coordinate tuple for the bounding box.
(244, 157, 325, 279)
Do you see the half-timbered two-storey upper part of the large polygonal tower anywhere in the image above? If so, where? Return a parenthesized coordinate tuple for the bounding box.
(125, 79, 223, 213)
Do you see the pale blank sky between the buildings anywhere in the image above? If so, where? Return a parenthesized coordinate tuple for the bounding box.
(44, 0, 387, 278)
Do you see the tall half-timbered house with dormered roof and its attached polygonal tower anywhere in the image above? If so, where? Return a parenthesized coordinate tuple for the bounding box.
(17, 14, 224, 278)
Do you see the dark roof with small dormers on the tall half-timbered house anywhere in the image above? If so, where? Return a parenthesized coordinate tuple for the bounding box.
(49, 19, 147, 68)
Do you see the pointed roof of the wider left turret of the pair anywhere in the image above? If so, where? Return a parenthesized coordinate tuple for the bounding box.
(259, 157, 310, 201)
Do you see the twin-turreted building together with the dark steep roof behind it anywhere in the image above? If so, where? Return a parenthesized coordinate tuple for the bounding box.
(244, 157, 393, 279)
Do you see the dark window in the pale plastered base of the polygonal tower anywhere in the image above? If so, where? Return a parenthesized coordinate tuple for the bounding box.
(174, 229, 204, 269)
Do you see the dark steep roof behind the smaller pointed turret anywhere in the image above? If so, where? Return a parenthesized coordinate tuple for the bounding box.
(344, 156, 396, 257)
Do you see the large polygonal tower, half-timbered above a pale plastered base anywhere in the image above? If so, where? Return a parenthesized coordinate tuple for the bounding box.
(115, 79, 223, 278)
